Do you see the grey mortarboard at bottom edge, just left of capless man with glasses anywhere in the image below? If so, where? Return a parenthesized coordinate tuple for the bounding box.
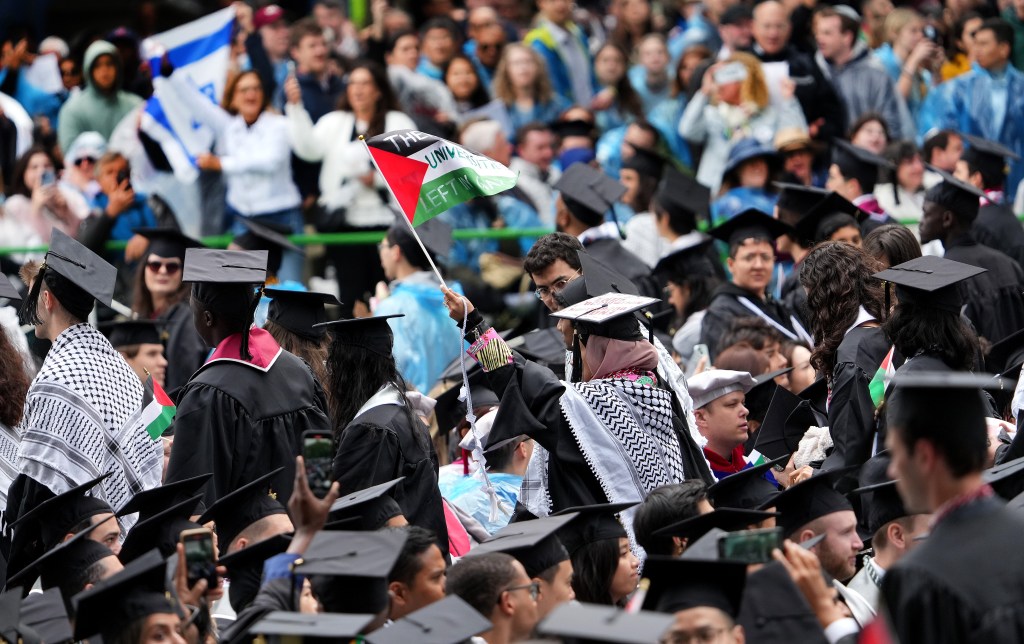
(366, 595, 492, 644)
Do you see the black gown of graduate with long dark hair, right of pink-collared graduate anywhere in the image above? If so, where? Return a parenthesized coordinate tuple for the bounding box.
(334, 404, 449, 555)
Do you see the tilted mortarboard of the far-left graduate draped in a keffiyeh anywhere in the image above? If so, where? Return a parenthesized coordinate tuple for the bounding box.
(18, 228, 118, 325)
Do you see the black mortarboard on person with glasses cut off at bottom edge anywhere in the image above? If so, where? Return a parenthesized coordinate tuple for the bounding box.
(643, 556, 746, 619)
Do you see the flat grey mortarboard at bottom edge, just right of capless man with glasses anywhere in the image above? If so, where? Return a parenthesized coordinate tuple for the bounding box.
(537, 603, 675, 644)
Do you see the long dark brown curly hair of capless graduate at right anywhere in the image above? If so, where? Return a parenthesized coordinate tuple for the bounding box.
(800, 242, 883, 379)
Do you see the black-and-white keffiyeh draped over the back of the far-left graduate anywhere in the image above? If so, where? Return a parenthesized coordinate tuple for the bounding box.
(17, 324, 163, 529)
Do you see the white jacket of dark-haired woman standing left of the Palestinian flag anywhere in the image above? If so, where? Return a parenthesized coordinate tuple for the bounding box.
(285, 103, 416, 227)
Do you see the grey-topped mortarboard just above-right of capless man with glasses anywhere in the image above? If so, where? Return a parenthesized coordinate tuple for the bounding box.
(467, 512, 580, 577)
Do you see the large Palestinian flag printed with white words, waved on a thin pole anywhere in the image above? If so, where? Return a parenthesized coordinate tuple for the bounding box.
(365, 130, 517, 226)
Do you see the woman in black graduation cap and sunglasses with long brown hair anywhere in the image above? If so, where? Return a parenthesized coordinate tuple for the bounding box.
(132, 228, 209, 391)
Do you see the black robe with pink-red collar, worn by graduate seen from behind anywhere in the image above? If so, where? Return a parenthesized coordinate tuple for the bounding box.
(165, 329, 331, 507)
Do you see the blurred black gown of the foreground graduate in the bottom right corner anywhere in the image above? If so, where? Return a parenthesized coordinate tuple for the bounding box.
(882, 498, 1024, 644)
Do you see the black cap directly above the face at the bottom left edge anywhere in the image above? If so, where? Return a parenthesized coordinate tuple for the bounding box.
(73, 550, 178, 642)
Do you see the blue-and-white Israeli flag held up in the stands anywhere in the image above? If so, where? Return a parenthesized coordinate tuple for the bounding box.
(141, 7, 234, 183)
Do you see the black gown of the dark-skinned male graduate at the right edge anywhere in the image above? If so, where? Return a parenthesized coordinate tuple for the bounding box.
(945, 233, 1024, 344)
